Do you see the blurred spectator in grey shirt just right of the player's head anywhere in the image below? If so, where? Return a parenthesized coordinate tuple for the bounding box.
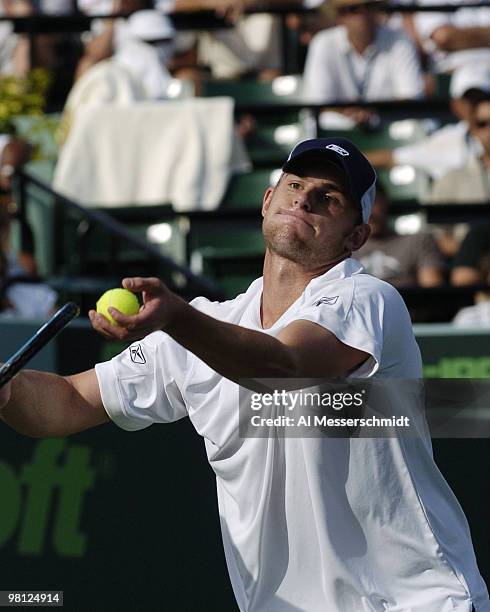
(355, 182, 445, 287)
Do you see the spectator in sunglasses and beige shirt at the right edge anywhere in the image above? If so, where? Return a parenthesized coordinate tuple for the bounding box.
(431, 91, 490, 204)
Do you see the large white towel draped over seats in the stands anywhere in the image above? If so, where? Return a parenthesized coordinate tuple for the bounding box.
(53, 97, 249, 211)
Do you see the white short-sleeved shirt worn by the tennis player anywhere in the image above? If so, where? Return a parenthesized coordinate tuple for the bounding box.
(96, 259, 490, 612)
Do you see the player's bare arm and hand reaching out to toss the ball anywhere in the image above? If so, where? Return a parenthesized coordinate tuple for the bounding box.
(89, 278, 369, 383)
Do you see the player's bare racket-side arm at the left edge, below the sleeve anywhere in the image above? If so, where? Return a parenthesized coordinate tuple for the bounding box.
(0, 370, 109, 438)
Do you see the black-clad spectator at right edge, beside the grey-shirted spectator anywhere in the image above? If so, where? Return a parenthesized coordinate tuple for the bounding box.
(451, 223, 490, 287)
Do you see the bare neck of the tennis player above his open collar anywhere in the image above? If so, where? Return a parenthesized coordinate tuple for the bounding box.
(261, 250, 346, 329)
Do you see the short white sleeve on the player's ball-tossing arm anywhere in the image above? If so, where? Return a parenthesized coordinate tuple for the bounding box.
(294, 279, 384, 377)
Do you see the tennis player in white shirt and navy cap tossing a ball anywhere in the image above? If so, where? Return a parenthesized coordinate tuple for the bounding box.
(2, 138, 490, 612)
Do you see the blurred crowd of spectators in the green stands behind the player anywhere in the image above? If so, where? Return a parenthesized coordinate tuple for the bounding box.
(0, 0, 490, 324)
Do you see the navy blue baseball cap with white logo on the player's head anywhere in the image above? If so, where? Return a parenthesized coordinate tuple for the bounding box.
(282, 138, 376, 223)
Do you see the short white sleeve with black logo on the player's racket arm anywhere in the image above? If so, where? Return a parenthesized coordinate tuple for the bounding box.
(95, 332, 189, 431)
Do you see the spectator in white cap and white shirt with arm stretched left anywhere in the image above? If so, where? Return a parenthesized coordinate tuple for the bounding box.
(366, 63, 490, 179)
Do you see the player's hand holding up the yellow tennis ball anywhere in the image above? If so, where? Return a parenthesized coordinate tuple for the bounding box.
(88, 277, 181, 342)
